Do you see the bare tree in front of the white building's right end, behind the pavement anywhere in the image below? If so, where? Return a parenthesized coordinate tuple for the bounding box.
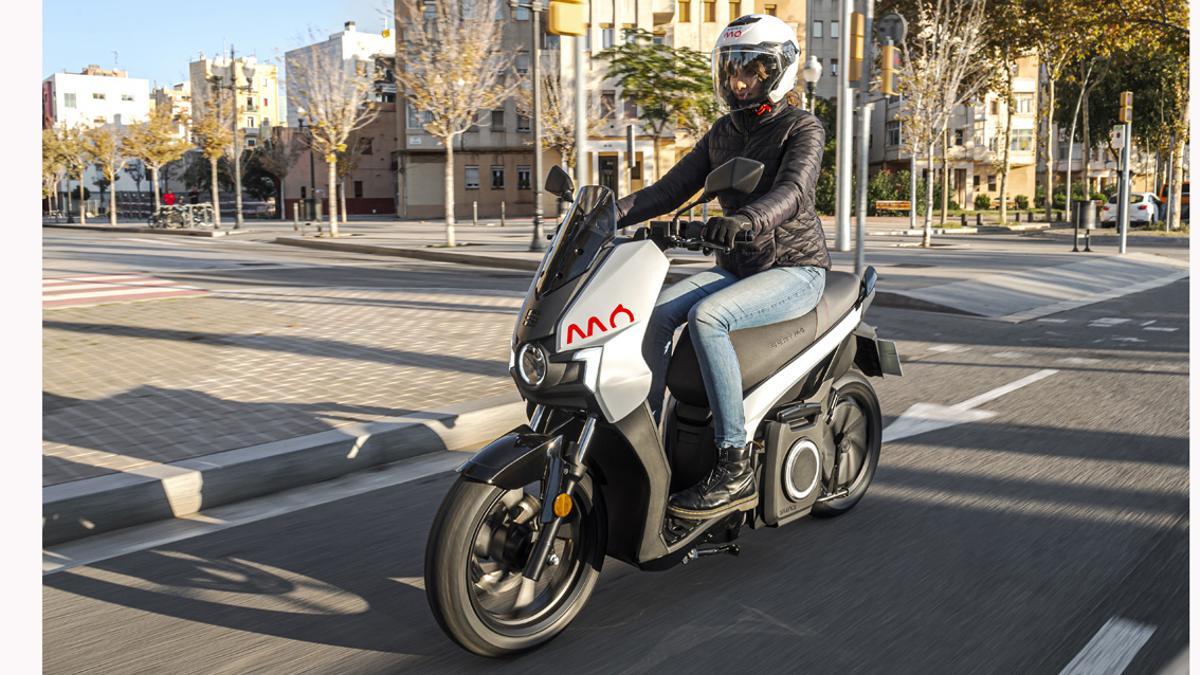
(287, 36, 379, 237)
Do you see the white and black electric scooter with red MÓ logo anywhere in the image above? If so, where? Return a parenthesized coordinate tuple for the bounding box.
(425, 157, 901, 656)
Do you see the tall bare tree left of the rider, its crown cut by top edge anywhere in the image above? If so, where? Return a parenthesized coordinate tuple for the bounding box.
(396, 0, 523, 246)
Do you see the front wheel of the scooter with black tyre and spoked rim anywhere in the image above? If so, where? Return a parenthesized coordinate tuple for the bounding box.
(425, 477, 607, 657)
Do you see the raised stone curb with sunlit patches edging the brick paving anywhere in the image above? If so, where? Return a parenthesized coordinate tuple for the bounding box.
(42, 393, 526, 545)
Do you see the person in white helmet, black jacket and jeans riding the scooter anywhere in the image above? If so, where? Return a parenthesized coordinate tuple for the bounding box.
(617, 14, 830, 520)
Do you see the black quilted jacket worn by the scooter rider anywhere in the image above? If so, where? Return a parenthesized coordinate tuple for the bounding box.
(617, 103, 830, 279)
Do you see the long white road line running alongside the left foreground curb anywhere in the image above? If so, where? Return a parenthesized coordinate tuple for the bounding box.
(42, 452, 472, 575)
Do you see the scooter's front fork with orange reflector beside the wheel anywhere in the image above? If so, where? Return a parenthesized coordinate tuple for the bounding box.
(517, 405, 596, 588)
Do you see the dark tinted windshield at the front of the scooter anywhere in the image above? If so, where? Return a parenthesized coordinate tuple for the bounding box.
(535, 185, 617, 297)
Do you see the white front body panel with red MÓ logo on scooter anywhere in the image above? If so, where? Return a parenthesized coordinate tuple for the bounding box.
(556, 240, 671, 423)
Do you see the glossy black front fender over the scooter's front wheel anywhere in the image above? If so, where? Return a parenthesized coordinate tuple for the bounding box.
(458, 424, 563, 490)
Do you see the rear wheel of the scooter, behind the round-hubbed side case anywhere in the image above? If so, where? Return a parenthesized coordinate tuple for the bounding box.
(812, 370, 883, 518)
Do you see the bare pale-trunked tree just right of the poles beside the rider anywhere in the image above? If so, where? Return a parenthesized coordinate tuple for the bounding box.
(900, 0, 991, 246)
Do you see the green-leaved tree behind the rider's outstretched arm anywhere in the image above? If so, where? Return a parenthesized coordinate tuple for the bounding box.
(598, 29, 718, 182)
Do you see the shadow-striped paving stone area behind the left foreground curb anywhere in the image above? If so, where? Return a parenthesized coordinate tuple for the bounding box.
(42, 282, 521, 486)
